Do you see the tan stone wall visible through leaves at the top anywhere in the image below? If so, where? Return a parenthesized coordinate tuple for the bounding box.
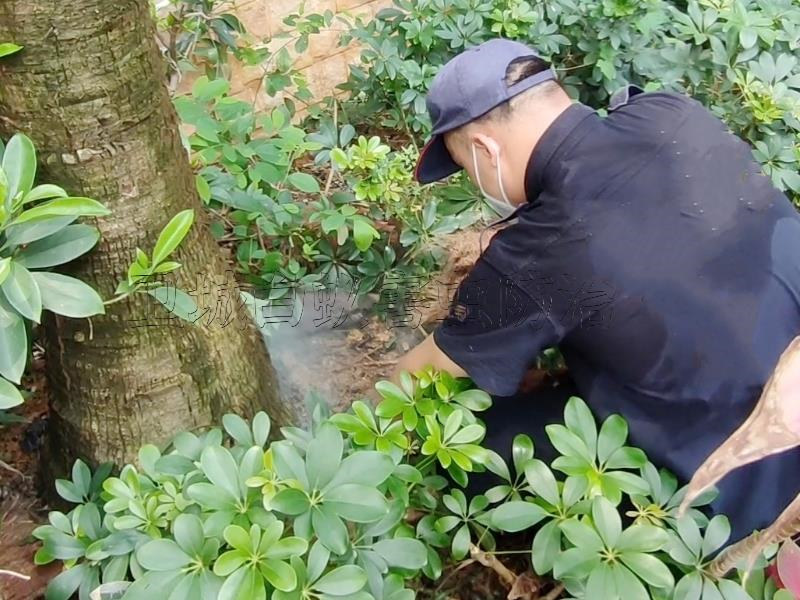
(220, 0, 392, 108)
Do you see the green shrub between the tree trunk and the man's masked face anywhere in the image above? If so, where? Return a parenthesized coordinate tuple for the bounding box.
(175, 77, 475, 302)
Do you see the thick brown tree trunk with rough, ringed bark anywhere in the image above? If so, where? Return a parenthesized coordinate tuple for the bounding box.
(0, 0, 293, 469)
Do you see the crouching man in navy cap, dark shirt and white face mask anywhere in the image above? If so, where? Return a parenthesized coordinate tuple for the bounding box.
(398, 40, 800, 539)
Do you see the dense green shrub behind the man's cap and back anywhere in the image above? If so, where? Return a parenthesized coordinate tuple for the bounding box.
(344, 0, 800, 200)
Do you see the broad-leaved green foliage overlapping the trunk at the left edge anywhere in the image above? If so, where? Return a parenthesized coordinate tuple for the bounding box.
(0, 134, 109, 416)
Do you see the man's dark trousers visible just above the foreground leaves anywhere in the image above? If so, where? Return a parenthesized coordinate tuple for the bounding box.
(467, 379, 579, 496)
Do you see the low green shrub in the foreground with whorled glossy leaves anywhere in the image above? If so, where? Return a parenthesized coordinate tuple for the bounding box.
(34, 370, 775, 600)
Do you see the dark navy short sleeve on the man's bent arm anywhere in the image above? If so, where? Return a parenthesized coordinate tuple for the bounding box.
(433, 258, 561, 396)
